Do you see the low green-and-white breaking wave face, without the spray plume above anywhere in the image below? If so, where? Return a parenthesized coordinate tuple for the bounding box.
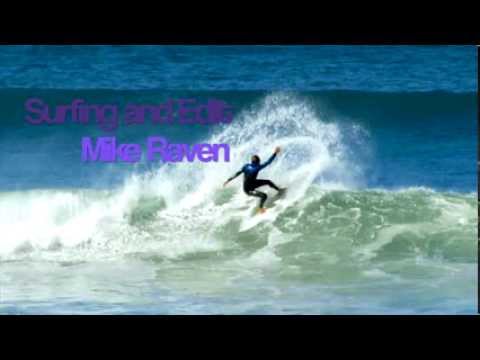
(0, 188, 477, 266)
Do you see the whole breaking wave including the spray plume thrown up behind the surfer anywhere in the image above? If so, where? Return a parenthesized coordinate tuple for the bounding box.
(0, 94, 477, 273)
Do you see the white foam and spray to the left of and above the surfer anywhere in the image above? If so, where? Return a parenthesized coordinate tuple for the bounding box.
(0, 94, 356, 258)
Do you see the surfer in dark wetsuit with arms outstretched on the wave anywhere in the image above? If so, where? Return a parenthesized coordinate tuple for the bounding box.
(223, 147, 285, 213)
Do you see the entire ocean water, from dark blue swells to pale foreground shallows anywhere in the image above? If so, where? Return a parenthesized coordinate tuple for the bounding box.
(0, 46, 478, 314)
